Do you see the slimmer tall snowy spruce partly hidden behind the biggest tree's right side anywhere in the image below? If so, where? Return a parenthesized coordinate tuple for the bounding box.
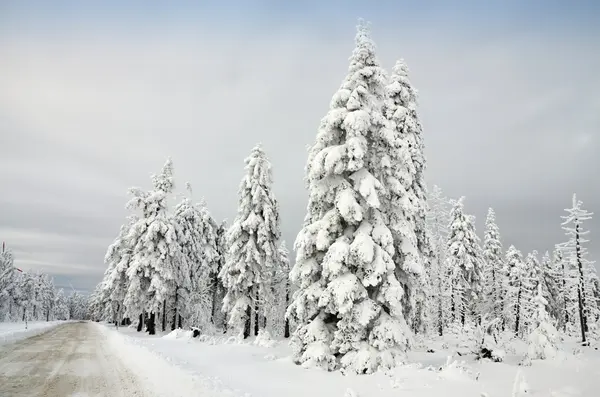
(384, 60, 433, 332)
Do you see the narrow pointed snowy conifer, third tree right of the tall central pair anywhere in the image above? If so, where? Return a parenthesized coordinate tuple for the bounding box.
(483, 208, 506, 319)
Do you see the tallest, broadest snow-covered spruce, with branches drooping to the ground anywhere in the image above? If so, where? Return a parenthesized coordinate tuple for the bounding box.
(288, 24, 410, 373)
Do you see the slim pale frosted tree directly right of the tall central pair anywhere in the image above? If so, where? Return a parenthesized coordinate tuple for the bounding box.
(427, 186, 450, 336)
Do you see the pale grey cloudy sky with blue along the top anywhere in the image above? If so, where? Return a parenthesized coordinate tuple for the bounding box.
(0, 0, 600, 291)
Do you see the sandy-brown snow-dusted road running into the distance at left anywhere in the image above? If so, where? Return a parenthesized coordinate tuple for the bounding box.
(0, 323, 150, 397)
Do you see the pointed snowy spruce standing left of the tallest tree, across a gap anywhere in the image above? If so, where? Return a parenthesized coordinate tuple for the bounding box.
(220, 145, 281, 337)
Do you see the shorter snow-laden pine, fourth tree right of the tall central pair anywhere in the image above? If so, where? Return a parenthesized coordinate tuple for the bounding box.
(504, 245, 532, 335)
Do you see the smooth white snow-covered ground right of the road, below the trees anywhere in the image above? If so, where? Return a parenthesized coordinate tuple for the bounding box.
(106, 327, 600, 397)
